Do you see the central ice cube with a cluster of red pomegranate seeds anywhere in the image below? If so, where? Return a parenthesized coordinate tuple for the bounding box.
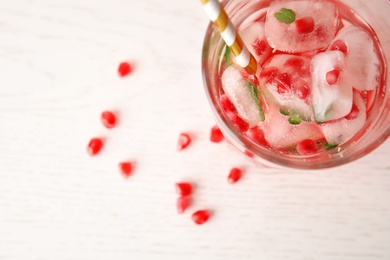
(260, 54, 313, 120)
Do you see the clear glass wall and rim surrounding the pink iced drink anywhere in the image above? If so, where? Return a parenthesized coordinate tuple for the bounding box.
(202, 0, 390, 169)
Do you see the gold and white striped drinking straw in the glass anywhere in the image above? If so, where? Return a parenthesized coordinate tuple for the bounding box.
(200, 0, 257, 74)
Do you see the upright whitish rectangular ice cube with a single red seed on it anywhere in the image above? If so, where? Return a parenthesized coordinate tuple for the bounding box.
(310, 50, 352, 122)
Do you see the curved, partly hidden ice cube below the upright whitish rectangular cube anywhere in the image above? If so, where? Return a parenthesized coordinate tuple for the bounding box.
(321, 91, 366, 144)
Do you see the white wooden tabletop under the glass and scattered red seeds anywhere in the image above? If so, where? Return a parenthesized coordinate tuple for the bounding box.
(0, 0, 390, 260)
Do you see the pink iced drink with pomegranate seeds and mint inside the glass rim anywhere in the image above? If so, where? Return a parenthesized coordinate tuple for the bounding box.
(220, 0, 385, 155)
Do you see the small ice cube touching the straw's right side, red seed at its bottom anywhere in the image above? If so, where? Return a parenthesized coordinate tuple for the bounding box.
(240, 22, 272, 65)
